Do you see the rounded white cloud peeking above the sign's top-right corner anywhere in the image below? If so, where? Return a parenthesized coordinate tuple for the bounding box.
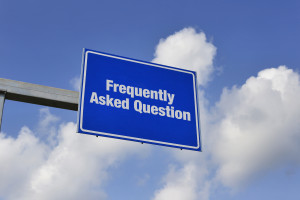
(152, 28, 216, 85)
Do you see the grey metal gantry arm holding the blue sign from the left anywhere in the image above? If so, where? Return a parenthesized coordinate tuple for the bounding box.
(0, 78, 79, 130)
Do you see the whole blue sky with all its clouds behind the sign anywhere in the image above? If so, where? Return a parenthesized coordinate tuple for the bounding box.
(0, 0, 300, 200)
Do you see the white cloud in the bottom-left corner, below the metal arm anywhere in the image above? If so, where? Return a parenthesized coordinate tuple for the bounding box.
(0, 127, 48, 199)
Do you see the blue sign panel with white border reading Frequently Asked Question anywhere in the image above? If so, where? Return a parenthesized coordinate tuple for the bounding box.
(77, 49, 201, 151)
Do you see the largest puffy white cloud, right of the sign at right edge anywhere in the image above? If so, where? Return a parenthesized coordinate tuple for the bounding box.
(211, 66, 300, 189)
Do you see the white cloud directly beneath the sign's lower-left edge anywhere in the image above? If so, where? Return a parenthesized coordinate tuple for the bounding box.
(25, 123, 143, 199)
